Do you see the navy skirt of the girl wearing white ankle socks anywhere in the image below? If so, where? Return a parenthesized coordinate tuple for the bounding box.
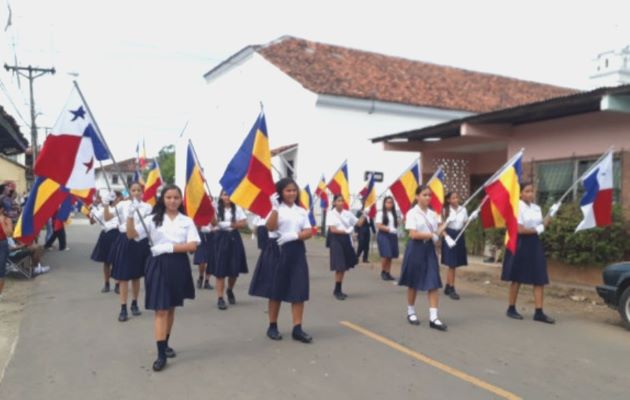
(398, 239, 442, 290)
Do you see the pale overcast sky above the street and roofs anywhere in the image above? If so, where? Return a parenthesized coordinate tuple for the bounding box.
(0, 0, 630, 159)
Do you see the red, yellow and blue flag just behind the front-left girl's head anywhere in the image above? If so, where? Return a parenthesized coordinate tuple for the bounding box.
(184, 141, 215, 226)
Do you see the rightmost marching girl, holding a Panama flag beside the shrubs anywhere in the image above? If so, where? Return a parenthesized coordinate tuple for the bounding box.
(501, 182, 559, 324)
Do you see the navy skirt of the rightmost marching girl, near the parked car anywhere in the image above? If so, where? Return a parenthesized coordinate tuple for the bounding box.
(501, 234, 549, 286)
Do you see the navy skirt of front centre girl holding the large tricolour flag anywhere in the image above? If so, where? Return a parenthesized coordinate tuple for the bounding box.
(249, 239, 309, 303)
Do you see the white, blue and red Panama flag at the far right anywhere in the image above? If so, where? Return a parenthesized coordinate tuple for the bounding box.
(575, 152, 613, 232)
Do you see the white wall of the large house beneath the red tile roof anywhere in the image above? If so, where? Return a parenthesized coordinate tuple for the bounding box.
(177, 53, 464, 209)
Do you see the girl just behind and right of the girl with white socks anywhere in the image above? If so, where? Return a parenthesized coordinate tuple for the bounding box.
(441, 192, 479, 300)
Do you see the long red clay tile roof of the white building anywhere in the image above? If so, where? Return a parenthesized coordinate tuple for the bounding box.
(255, 37, 577, 113)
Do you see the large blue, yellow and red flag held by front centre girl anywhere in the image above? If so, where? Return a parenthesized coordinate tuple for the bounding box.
(220, 112, 276, 218)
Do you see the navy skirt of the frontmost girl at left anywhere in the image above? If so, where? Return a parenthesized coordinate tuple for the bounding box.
(144, 253, 195, 310)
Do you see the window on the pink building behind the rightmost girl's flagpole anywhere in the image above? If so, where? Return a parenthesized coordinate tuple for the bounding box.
(536, 158, 621, 204)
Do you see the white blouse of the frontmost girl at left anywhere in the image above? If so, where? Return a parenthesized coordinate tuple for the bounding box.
(136, 213, 201, 246)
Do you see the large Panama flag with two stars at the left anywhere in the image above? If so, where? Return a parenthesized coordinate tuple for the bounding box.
(35, 87, 109, 189)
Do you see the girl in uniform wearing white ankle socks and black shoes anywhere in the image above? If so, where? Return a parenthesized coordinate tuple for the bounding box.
(398, 185, 447, 331)
